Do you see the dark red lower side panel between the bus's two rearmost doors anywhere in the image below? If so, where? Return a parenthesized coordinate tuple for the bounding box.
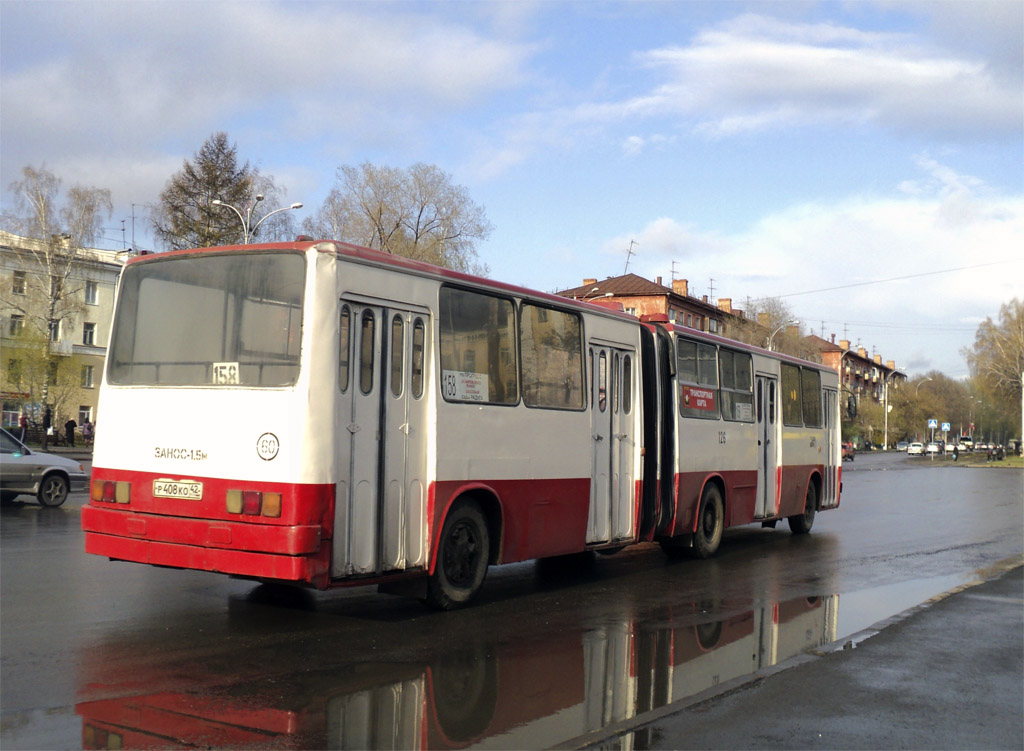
(431, 477, 590, 564)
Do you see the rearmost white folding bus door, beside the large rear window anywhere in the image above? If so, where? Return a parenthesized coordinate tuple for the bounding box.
(331, 300, 430, 576)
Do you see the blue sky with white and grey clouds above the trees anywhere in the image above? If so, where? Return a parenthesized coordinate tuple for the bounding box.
(0, 0, 1024, 378)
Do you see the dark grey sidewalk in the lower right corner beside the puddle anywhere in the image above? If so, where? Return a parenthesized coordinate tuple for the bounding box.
(582, 562, 1024, 749)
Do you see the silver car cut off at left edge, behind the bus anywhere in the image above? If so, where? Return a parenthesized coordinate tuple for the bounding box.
(0, 428, 89, 507)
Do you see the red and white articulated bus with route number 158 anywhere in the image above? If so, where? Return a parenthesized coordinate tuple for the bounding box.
(82, 242, 842, 609)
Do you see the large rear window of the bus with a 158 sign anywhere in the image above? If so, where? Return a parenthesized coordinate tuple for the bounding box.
(106, 252, 305, 386)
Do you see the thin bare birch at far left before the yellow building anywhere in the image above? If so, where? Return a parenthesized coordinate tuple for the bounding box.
(0, 166, 113, 404)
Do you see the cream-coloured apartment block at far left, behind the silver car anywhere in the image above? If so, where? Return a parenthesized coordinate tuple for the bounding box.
(0, 232, 128, 425)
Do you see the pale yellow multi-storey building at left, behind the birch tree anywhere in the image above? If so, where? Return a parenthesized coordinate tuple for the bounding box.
(0, 232, 127, 425)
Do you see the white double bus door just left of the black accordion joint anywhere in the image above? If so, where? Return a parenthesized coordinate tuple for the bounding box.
(587, 343, 637, 543)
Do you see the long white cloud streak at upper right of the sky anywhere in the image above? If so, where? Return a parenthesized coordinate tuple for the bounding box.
(638, 14, 1024, 137)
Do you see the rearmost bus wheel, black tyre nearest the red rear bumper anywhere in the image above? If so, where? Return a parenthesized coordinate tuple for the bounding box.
(425, 501, 490, 611)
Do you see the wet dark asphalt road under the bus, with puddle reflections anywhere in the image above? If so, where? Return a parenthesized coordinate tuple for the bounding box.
(0, 454, 1024, 749)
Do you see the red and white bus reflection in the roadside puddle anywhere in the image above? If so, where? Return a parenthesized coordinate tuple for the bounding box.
(76, 595, 839, 749)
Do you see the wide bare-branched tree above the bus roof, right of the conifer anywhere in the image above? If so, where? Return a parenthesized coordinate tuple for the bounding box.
(303, 163, 494, 275)
